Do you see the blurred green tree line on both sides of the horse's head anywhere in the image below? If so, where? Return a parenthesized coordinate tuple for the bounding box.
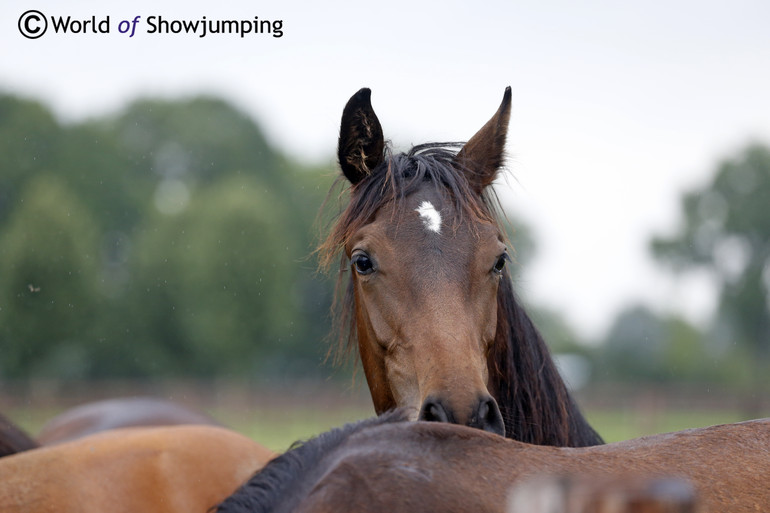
(0, 94, 770, 385)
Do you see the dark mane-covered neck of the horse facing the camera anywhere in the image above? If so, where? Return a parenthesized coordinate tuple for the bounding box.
(489, 276, 603, 447)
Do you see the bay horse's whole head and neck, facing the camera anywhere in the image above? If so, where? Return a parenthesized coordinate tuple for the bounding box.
(322, 88, 601, 445)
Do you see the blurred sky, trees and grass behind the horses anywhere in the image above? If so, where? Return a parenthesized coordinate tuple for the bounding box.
(0, 1, 770, 449)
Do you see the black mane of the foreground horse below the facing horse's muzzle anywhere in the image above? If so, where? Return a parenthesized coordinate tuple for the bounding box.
(216, 410, 408, 513)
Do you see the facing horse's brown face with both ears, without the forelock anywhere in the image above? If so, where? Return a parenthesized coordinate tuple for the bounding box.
(338, 88, 511, 434)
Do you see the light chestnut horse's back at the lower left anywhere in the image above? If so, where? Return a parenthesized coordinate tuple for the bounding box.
(0, 426, 275, 513)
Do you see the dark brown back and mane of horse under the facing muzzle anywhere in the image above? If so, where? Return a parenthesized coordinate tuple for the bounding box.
(216, 410, 770, 513)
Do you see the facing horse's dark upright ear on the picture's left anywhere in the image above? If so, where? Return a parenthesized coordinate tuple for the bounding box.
(337, 88, 385, 185)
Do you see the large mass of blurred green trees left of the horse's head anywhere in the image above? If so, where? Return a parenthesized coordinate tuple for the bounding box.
(0, 96, 332, 378)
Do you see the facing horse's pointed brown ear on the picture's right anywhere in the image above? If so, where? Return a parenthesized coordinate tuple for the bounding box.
(455, 86, 511, 193)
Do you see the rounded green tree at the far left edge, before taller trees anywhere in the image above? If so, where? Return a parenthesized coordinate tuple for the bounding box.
(0, 175, 99, 377)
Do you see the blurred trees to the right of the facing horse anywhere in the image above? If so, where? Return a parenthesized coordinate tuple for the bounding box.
(576, 142, 770, 390)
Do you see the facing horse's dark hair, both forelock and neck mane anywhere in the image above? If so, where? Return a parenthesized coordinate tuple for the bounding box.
(318, 143, 603, 447)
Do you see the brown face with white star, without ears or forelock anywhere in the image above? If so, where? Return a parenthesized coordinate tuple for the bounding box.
(346, 187, 508, 434)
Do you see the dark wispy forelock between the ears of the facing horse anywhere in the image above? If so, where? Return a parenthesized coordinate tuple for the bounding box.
(318, 143, 503, 363)
